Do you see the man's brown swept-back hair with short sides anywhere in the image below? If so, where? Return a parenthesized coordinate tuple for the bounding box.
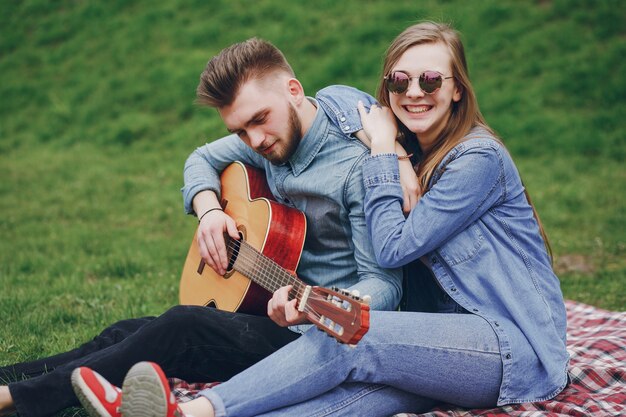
(196, 38, 295, 108)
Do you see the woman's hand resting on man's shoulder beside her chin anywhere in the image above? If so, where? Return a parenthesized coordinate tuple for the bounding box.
(357, 100, 398, 155)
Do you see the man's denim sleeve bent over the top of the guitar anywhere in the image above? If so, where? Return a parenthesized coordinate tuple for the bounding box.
(181, 135, 264, 214)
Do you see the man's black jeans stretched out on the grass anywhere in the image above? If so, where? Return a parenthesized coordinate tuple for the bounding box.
(0, 306, 299, 417)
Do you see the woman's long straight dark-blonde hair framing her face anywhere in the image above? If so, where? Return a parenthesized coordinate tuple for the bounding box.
(377, 21, 552, 259)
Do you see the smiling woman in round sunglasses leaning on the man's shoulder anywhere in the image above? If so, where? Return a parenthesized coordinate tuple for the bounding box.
(75, 22, 568, 417)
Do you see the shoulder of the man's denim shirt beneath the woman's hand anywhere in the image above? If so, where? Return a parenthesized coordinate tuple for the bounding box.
(315, 85, 378, 135)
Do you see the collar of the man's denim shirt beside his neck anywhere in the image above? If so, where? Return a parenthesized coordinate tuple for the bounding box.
(289, 97, 330, 177)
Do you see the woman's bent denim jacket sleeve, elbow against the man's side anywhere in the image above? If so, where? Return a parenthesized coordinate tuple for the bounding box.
(363, 140, 506, 267)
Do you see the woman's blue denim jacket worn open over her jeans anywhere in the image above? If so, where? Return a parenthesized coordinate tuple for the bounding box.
(318, 87, 569, 405)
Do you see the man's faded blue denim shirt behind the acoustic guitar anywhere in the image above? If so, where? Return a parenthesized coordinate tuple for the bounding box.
(182, 98, 402, 322)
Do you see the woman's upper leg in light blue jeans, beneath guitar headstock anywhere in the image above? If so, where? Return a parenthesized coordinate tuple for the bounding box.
(201, 311, 502, 416)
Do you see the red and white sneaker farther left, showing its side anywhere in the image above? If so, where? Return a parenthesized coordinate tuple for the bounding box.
(72, 367, 122, 417)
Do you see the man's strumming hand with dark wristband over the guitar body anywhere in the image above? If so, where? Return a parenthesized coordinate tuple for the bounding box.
(193, 190, 239, 275)
